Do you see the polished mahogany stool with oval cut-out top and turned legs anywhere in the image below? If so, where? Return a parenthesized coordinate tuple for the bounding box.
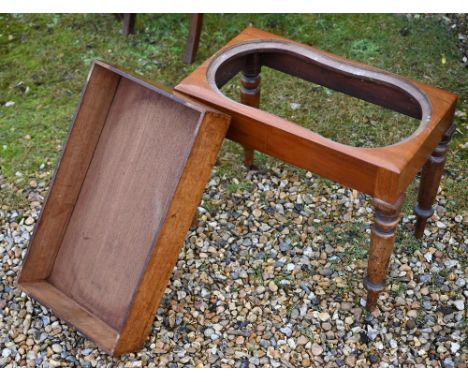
(175, 27, 457, 310)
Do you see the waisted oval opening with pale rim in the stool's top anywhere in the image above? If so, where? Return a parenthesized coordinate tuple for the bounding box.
(208, 41, 431, 147)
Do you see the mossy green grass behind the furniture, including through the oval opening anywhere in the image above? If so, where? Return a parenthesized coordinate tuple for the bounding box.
(0, 14, 468, 209)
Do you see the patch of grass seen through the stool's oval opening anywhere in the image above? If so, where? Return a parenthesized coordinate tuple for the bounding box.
(224, 67, 420, 147)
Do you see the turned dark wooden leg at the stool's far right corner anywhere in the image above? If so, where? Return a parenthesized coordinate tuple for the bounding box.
(414, 125, 456, 239)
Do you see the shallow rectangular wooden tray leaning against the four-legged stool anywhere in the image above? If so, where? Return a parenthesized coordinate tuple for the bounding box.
(18, 62, 230, 355)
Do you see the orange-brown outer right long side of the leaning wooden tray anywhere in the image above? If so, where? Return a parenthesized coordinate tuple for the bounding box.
(114, 112, 229, 355)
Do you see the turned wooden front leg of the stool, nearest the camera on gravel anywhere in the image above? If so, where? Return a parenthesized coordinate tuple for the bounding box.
(364, 194, 404, 310)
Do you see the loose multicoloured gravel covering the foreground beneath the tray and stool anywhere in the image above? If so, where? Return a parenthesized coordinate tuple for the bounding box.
(0, 157, 468, 367)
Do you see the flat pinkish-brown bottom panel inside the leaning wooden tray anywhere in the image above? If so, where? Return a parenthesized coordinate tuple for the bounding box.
(49, 78, 201, 331)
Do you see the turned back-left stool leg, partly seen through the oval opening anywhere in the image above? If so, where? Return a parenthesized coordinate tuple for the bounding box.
(240, 54, 261, 167)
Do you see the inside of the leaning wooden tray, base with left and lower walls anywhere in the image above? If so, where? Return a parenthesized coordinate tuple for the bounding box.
(19, 67, 202, 349)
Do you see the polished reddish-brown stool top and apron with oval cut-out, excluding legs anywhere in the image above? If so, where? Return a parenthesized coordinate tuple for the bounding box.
(175, 27, 457, 203)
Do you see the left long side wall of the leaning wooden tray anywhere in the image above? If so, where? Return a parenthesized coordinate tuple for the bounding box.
(19, 65, 120, 283)
